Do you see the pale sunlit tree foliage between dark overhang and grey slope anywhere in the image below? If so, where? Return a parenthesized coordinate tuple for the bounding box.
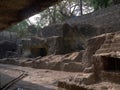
(28, 0, 93, 28)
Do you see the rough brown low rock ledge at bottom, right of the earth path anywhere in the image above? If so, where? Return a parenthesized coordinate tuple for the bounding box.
(58, 73, 95, 90)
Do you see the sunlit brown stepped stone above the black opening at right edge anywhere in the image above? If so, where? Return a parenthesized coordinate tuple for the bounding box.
(96, 32, 120, 55)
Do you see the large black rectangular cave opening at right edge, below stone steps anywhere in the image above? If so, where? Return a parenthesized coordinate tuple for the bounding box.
(102, 56, 120, 72)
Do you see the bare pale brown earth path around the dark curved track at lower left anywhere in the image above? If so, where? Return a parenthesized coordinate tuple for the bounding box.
(0, 64, 82, 90)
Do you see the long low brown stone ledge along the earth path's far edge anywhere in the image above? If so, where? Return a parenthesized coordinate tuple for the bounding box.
(21, 61, 84, 72)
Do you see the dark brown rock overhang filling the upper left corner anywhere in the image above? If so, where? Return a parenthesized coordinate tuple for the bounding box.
(0, 0, 61, 30)
